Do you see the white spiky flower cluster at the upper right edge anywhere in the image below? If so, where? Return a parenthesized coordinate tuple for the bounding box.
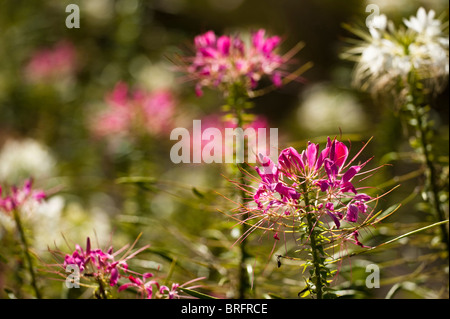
(348, 8, 449, 92)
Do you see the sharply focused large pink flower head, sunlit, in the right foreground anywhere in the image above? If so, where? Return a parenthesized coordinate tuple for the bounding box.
(253, 138, 372, 229)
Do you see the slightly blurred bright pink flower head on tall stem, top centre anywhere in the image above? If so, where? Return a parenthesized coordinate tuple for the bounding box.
(187, 29, 286, 96)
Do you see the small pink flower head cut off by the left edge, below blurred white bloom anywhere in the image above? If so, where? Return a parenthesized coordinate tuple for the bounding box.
(0, 179, 46, 213)
